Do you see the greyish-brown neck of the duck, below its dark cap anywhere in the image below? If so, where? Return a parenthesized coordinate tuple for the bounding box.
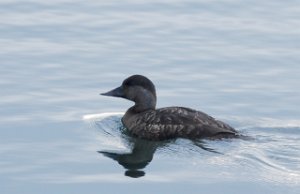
(130, 92, 156, 113)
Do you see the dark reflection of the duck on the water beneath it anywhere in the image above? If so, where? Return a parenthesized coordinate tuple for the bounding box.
(98, 138, 218, 178)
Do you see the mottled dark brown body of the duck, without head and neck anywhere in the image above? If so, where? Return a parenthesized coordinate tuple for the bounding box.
(122, 107, 237, 140)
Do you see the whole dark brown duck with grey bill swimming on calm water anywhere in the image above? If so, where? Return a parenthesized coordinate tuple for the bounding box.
(101, 75, 239, 141)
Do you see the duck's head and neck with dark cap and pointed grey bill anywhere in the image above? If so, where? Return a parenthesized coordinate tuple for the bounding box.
(101, 75, 156, 112)
